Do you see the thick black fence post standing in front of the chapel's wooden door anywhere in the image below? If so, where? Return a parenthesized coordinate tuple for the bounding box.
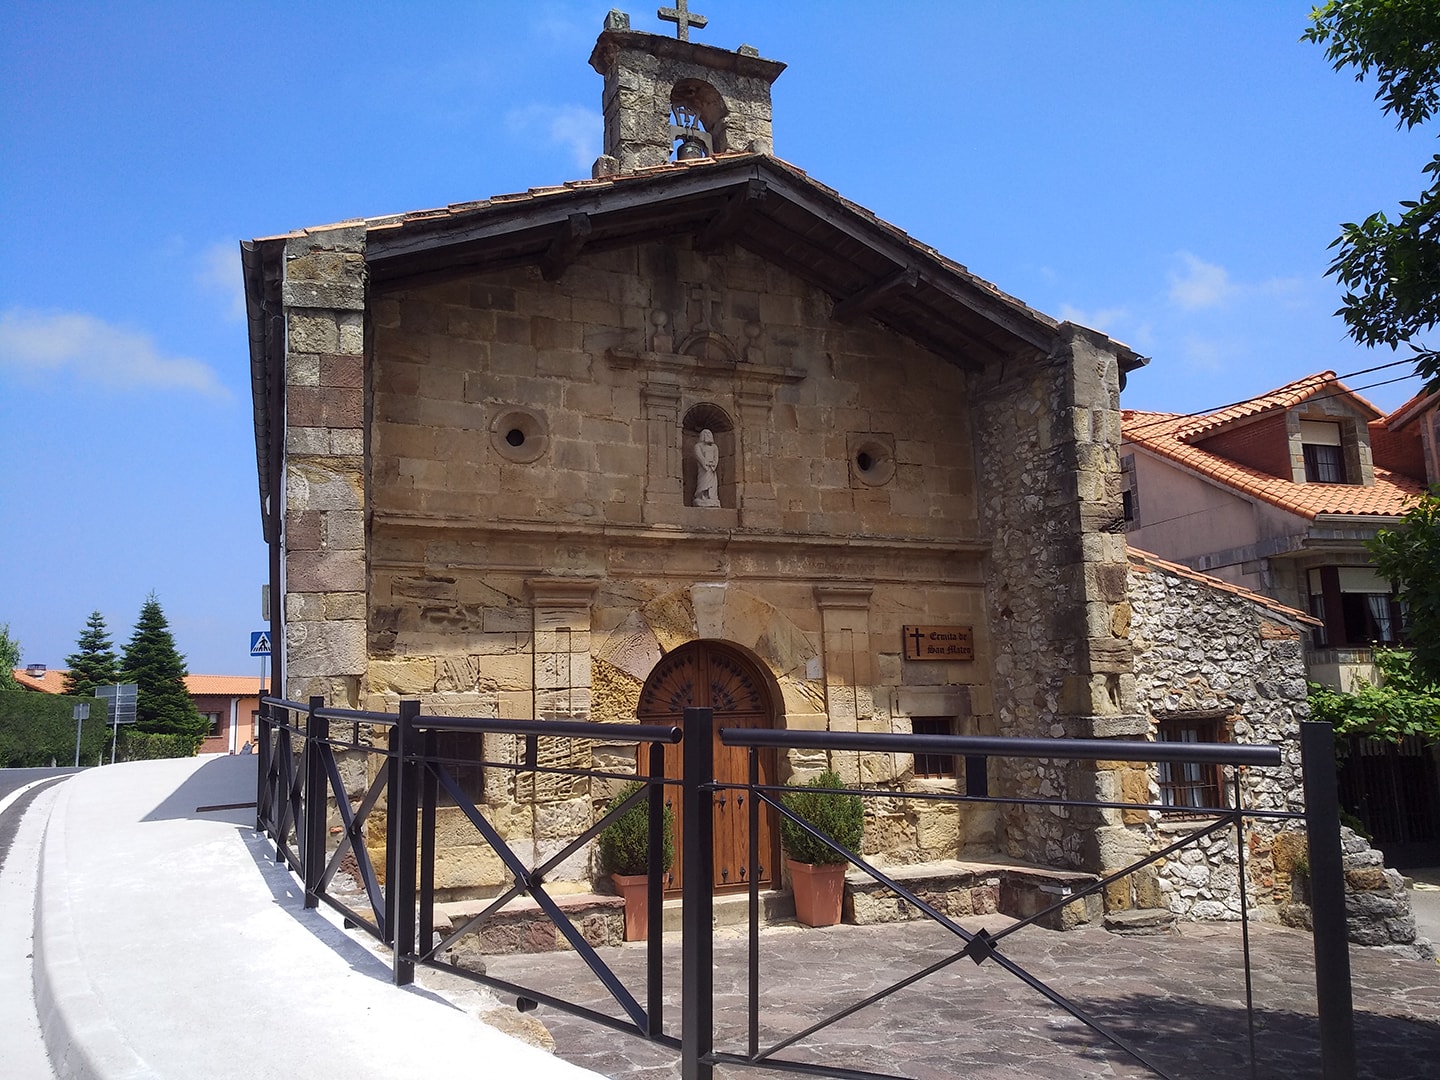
(680, 708, 716, 1080)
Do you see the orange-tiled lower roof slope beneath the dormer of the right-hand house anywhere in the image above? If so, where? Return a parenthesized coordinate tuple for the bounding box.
(1120, 403, 1424, 520)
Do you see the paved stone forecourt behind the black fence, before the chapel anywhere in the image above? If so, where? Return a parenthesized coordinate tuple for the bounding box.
(488, 919, 1440, 1080)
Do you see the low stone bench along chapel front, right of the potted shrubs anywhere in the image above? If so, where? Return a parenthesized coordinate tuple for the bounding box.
(842, 860, 1104, 930)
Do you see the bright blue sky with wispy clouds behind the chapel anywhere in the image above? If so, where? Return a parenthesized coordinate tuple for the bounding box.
(0, 0, 1433, 674)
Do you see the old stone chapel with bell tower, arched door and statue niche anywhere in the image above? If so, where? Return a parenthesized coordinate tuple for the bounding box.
(242, 12, 1203, 910)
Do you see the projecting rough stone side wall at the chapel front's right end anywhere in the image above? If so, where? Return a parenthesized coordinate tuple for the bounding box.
(975, 325, 1143, 871)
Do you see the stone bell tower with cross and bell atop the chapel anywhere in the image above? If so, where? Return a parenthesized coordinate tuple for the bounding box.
(590, 0, 785, 177)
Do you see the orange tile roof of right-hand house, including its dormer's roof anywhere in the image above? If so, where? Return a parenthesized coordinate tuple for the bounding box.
(1120, 372, 1426, 520)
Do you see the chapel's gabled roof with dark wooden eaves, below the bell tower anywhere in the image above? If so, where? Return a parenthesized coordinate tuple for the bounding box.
(242, 154, 1145, 536)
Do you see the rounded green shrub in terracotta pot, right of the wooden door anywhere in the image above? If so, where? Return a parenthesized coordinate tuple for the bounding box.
(780, 769, 865, 926)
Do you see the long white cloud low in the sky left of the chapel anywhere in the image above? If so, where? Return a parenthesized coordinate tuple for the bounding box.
(0, 308, 230, 397)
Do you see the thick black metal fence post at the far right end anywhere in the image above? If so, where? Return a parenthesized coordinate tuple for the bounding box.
(1300, 721, 1355, 1080)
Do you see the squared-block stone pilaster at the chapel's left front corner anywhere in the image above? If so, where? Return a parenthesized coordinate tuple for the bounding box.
(281, 225, 366, 706)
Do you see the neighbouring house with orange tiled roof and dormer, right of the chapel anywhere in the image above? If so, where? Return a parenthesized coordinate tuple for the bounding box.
(1120, 372, 1434, 690)
